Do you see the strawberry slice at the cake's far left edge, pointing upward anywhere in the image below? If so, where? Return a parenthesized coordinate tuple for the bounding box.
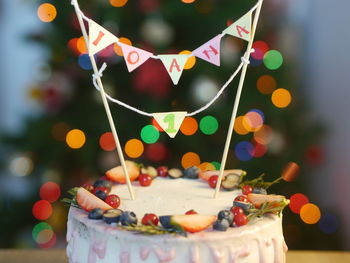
(75, 187, 113, 212)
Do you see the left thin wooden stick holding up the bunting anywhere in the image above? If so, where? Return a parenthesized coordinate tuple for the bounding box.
(72, 1, 135, 200)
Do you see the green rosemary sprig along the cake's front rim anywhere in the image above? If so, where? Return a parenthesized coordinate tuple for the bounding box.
(117, 225, 187, 237)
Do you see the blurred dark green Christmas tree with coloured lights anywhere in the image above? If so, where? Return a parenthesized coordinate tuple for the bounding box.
(0, 0, 338, 252)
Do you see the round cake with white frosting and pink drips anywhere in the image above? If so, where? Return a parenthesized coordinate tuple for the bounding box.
(67, 164, 288, 263)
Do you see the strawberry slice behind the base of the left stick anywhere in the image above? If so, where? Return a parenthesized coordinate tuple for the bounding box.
(106, 161, 140, 184)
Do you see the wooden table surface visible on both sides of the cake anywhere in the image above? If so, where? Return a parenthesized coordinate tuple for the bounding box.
(0, 249, 350, 263)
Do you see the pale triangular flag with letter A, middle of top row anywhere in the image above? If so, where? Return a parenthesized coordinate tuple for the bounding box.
(158, 55, 188, 85)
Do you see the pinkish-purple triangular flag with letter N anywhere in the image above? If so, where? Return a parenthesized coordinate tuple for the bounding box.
(192, 34, 222, 66)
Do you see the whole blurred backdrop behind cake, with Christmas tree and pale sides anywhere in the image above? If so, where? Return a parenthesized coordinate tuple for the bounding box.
(0, 0, 350, 250)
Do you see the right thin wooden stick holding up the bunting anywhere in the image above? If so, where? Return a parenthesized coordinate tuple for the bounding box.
(214, 0, 263, 198)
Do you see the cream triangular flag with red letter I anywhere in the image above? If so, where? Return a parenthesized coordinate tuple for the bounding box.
(89, 20, 118, 56)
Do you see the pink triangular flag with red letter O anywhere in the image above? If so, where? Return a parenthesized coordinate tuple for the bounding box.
(118, 43, 153, 72)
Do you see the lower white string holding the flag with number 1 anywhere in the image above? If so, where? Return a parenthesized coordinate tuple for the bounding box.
(92, 49, 254, 117)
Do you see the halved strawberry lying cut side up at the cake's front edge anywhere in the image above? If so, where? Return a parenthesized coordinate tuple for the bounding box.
(159, 214, 216, 233)
